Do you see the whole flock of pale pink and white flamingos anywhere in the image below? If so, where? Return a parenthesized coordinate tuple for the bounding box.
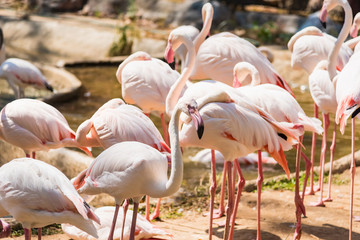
(0, 0, 360, 240)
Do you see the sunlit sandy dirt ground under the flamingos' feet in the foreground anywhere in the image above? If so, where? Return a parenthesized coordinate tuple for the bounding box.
(2, 167, 360, 240)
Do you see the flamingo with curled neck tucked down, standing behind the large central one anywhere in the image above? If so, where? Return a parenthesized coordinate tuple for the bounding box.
(234, 62, 323, 239)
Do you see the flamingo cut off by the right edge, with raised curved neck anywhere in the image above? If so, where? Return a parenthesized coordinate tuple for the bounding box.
(320, 0, 360, 240)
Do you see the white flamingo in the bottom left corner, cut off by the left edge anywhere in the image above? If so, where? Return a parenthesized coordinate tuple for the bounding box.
(0, 158, 100, 240)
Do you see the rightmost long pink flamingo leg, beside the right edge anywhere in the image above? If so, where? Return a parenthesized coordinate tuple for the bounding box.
(349, 118, 356, 240)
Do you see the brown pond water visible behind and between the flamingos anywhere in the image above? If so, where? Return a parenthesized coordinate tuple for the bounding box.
(50, 66, 358, 188)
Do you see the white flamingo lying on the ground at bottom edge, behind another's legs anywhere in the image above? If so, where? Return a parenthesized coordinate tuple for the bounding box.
(61, 206, 171, 240)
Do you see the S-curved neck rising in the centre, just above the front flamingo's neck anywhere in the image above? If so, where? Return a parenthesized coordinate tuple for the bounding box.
(166, 36, 195, 116)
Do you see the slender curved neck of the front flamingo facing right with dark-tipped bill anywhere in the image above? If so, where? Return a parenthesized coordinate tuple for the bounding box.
(164, 103, 184, 195)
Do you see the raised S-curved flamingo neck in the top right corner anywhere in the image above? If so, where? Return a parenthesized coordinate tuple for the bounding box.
(328, 1, 353, 80)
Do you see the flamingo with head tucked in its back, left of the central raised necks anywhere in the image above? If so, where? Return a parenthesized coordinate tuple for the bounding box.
(116, 51, 188, 144)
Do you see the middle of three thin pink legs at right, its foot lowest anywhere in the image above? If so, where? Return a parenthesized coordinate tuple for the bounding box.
(311, 113, 330, 207)
